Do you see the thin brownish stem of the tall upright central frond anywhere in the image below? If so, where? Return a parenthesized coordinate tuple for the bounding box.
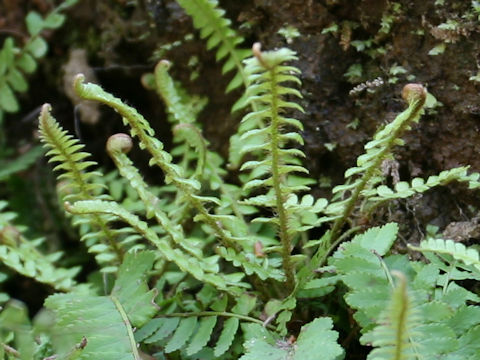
(266, 58, 295, 291)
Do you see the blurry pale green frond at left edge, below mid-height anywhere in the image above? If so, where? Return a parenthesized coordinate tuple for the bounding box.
(0, 201, 80, 291)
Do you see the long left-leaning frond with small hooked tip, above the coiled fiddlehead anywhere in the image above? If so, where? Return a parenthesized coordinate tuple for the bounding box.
(74, 75, 277, 278)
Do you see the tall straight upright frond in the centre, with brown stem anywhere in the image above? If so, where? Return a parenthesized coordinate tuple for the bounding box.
(241, 43, 308, 290)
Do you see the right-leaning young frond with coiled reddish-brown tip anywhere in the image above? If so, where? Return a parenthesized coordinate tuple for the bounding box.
(326, 84, 427, 243)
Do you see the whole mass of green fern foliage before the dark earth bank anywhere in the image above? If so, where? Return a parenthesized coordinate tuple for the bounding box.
(0, 0, 480, 360)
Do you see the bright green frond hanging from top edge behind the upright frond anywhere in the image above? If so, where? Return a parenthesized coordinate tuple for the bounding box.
(177, 0, 251, 92)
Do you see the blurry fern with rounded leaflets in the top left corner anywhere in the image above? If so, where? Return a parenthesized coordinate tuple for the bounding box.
(0, 0, 78, 124)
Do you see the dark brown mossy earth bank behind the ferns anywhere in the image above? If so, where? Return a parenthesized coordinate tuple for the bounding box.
(0, 0, 480, 354)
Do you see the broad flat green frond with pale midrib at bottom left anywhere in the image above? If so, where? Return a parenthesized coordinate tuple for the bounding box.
(45, 252, 157, 360)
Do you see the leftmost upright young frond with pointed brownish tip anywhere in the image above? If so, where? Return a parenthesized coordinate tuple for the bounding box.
(39, 104, 124, 265)
